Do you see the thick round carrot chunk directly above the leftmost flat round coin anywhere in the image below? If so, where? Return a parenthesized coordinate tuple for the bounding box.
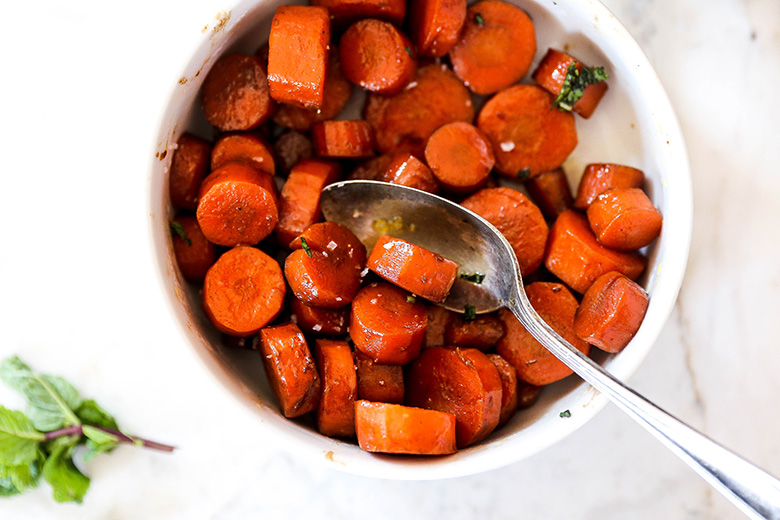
(197, 163, 279, 246)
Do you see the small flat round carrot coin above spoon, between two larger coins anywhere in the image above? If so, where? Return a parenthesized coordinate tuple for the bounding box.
(425, 122, 496, 193)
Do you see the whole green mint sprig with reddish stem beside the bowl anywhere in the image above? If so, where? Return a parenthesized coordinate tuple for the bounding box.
(0, 356, 174, 503)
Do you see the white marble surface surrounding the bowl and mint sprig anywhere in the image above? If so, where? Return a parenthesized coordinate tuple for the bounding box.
(0, 0, 780, 520)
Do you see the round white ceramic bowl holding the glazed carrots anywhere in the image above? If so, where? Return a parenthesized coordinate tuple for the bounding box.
(149, 0, 692, 479)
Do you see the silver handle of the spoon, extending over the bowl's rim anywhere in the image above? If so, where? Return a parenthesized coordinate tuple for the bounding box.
(508, 294, 780, 520)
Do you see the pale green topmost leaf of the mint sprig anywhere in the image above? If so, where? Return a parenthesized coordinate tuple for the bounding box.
(0, 356, 81, 432)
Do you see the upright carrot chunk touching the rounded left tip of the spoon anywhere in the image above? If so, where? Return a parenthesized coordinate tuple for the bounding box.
(276, 159, 341, 246)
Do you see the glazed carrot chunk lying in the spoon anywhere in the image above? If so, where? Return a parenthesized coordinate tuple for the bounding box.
(366, 235, 458, 302)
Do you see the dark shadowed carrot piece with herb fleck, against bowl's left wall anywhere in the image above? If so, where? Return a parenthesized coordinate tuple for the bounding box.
(171, 215, 217, 282)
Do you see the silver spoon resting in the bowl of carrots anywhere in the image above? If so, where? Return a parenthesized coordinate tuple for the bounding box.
(321, 181, 780, 520)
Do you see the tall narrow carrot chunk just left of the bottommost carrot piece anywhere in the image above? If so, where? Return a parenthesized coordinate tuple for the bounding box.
(314, 339, 357, 437)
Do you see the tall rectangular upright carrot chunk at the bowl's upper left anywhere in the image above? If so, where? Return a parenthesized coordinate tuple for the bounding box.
(268, 5, 330, 110)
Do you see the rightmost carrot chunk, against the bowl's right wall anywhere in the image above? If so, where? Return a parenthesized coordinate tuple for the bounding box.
(587, 188, 663, 251)
